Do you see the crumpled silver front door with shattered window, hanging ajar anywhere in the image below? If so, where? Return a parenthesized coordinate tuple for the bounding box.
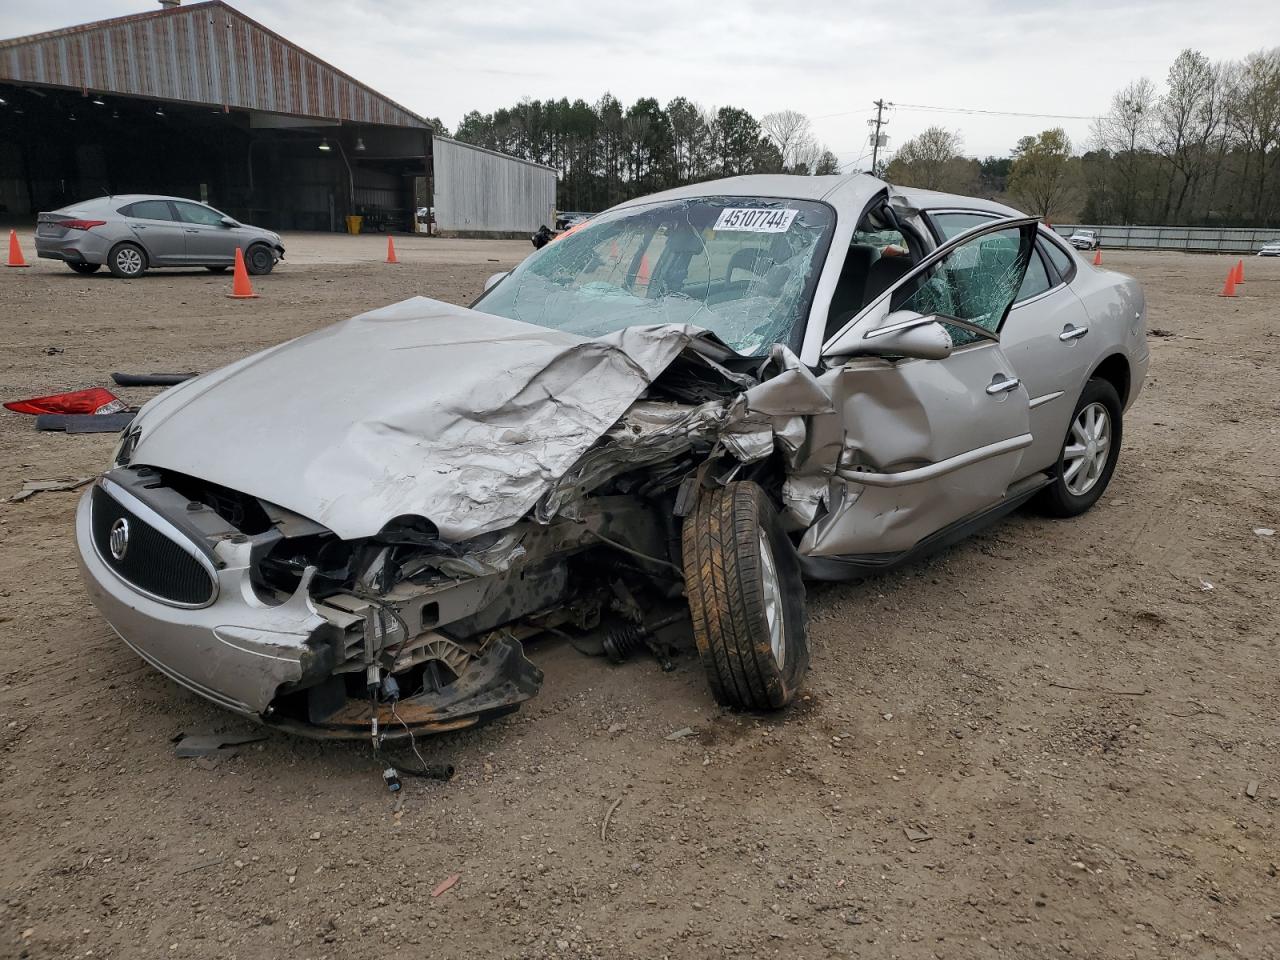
(800, 219, 1036, 561)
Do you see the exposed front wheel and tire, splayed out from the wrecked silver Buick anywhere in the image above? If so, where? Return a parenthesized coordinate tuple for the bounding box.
(681, 483, 809, 710)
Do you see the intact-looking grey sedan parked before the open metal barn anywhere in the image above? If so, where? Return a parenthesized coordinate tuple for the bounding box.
(36, 195, 284, 276)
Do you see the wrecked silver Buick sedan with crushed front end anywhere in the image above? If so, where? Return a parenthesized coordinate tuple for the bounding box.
(77, 175, 1148, 739)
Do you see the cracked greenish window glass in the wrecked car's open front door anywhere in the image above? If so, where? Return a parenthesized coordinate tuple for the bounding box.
(892, 227, 1030, 347)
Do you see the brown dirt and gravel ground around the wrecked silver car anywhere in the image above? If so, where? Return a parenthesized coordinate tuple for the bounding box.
(0, 237, 1280, 960)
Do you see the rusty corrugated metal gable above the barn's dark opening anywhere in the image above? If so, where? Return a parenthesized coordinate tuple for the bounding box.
(0, 0, 428, 128)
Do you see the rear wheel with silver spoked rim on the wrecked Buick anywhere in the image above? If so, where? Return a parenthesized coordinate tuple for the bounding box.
(1039, 378, 1124, 517)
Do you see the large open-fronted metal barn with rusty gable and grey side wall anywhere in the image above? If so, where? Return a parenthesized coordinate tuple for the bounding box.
(0, 0, 554, 236)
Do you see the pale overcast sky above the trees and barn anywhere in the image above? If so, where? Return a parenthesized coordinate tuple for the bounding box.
(0, 0, 1280, 166)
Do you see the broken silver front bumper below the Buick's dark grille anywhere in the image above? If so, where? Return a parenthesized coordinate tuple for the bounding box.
(76, 488, 329, 717)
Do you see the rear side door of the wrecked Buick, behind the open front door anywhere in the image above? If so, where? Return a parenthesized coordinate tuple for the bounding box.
(928, 210, 1092, 470)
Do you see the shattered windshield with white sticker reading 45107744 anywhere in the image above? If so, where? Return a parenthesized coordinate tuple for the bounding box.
(475, 197, 835, 356)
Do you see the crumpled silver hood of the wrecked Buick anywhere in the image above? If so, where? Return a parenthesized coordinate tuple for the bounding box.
(133, 297, 724, 541)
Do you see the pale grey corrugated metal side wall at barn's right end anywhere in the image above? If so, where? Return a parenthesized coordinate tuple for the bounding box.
(431, 137, 556, 234)
